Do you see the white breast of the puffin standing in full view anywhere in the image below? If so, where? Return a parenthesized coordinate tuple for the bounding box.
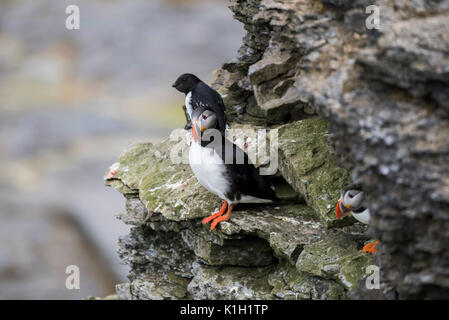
(189, 142, 230, 200)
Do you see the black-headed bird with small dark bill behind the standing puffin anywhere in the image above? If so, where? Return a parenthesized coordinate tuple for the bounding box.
(172, 73, 226, 136)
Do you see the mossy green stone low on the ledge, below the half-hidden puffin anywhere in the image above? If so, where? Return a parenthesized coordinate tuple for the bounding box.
(296, 234, 372, 289)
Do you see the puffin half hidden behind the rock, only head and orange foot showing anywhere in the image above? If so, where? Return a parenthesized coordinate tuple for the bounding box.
(335, 184, 379, 254)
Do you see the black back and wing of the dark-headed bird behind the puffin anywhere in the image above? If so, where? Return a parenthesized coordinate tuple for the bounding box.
(191, 82, 226, 135)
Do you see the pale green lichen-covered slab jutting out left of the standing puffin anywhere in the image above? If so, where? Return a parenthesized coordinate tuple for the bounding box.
(103, 129, 220, 220)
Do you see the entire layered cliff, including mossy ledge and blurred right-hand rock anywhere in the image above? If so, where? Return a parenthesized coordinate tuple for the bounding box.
(107, 0, 449, 299)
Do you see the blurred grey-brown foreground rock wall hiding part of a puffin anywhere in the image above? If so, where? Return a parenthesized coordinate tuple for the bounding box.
(286, 1, 449, 299)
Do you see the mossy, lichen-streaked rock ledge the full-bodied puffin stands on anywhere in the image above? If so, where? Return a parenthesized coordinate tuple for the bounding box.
(105, 117, 372, 299)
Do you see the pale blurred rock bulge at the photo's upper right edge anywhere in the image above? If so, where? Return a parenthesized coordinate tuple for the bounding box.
(358, 13, 449, 111)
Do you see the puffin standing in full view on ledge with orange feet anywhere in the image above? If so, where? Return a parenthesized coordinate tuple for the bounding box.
(189, 106, 279, 230)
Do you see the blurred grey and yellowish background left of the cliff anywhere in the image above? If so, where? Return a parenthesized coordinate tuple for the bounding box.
(0, 0, 244, 299)
